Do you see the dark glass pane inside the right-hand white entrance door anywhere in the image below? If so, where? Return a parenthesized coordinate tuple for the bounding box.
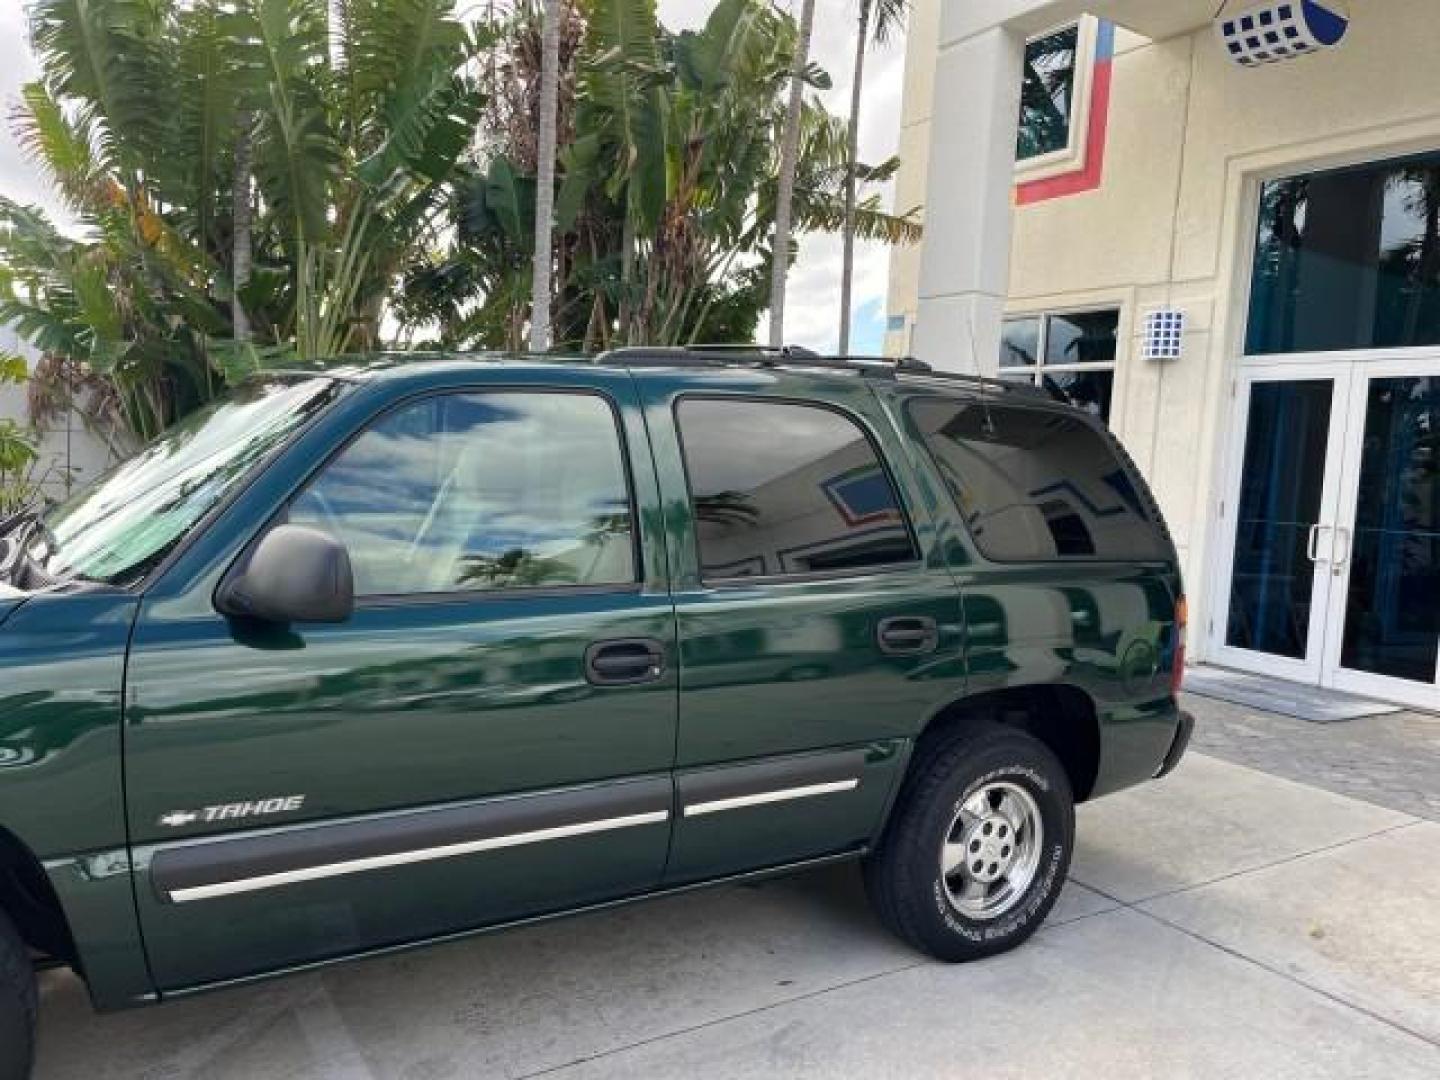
(1341, 377, 1440, 683)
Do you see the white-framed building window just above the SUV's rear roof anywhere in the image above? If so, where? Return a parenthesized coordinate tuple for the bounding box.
(999, 308, 1120, 423)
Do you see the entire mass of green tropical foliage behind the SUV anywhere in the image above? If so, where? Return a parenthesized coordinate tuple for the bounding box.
(0, 0, 917, 438)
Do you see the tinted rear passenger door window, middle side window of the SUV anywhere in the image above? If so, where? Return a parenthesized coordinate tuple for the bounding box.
(678, 399, 919, 580)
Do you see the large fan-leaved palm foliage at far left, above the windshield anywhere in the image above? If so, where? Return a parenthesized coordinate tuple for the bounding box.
(0, 0, 482, 436)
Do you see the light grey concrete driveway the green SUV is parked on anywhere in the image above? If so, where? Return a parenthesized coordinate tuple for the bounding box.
(30, 755, 1440, 1080)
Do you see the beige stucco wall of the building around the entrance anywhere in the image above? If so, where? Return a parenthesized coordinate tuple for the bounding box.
(887, 0, 1440, 659)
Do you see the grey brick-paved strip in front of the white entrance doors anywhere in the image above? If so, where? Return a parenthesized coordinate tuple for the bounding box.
(1184, 694, 1440, 821)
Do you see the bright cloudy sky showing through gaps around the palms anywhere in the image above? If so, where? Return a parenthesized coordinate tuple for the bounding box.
(0, 0, 904, 353)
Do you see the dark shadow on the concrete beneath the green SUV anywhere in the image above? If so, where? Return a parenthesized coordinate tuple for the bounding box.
(37, 863, 926, 1080)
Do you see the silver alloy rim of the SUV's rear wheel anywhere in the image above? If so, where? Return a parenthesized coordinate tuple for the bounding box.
(940, 780, 1045, 920)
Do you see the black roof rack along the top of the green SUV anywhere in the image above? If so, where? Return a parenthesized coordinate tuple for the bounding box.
(595, 344, 1074, 405)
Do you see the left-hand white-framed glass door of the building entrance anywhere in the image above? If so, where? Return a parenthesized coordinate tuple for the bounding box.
(1211, 363, 1352, 683)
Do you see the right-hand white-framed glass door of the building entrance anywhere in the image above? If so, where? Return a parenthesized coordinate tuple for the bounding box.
(1319, 360, 1440, 710)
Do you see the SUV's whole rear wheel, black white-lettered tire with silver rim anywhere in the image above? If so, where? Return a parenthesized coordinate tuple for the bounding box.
(865, 726, 1074, 962)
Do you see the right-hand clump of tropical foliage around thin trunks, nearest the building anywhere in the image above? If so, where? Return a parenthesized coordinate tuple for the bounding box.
(400, 0, 919, 350)
